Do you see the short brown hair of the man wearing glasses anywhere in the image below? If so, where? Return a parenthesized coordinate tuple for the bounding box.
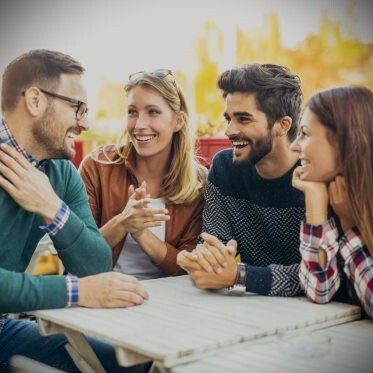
(1, 49, 84, 113)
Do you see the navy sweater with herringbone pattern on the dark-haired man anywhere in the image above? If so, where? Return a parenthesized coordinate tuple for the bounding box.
(203, 149, 304, 296)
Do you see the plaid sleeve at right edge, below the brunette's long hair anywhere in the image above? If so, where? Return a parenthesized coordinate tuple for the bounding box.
(340, 227, 373, 318)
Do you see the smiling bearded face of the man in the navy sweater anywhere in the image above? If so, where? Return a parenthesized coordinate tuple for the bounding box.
(224, 92, 273, 165)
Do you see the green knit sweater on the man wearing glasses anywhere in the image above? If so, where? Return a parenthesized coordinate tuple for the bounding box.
(0, 160, 112, 314)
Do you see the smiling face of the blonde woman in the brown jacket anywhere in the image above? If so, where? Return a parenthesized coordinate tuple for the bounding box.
(127, 86, 181, 159)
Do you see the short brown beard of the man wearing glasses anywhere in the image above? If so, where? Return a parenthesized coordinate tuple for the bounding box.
(32, 106, 75, 159)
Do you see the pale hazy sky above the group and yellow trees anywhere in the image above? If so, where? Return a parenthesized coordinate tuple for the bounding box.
(0, 0, 373, 103)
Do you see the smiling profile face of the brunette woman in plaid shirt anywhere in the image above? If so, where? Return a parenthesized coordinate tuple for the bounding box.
(291, 107, 340, 182)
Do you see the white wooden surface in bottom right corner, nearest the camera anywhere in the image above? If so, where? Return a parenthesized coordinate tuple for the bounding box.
(172, 320, 373, 373)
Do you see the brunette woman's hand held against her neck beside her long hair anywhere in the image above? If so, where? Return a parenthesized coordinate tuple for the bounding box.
(329, 176, 356, 232)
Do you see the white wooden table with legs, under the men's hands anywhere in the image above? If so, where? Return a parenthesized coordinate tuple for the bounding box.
(34, 276, 360, 372)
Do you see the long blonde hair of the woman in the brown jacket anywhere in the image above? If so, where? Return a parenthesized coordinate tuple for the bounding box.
(107, 70, 204, 204)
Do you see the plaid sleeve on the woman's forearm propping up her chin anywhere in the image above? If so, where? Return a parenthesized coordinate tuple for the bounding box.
(299, 218, 340, 303)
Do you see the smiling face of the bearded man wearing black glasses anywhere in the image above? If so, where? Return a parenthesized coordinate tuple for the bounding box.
(32, 74, 88, 159)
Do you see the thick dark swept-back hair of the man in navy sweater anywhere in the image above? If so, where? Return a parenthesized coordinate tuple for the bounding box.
(218, 63, 303, 142)
